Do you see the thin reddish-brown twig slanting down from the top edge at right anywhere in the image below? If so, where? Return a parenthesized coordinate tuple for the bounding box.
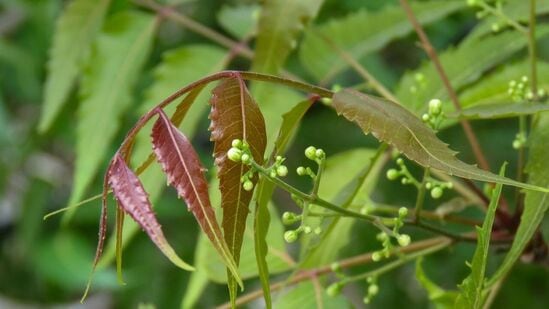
(400, 0, 490, 171)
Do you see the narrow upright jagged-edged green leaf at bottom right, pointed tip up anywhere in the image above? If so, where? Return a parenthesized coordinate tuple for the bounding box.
(456, 164, 506, 309)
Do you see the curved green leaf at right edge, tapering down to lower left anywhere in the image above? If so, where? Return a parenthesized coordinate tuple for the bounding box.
(488, 113, 549, 286)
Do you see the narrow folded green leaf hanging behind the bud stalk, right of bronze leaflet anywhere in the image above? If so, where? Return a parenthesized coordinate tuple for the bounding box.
(254, 100, 313, 308)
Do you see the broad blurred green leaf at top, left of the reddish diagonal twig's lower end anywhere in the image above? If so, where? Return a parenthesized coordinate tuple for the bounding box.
(299, 1, 464, 80)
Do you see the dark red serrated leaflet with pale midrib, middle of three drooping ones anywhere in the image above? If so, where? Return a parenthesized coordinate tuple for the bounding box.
(151, 111, 242, 284)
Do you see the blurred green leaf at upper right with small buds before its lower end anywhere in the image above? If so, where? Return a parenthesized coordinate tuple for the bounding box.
(396, 25, 549, 115)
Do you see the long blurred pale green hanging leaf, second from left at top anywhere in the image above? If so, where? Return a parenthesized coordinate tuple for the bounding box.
(64, 11, 156, 222)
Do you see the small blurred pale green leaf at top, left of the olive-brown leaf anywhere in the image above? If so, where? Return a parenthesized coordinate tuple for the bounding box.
(217, 4, 260, 40)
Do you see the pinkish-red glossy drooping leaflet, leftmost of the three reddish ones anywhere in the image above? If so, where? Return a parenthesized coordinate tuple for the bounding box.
(107, 153, 194, 270)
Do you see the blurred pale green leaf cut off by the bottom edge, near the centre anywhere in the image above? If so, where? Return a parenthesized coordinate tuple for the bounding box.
(274, 282, 350, 309)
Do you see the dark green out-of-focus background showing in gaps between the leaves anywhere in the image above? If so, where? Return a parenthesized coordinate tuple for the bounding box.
(0, 0, 549, 308)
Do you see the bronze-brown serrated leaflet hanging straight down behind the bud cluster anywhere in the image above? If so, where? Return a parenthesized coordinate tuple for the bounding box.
(210, 76, 267, 294)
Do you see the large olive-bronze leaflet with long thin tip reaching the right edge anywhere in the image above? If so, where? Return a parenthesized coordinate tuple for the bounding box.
(333, 89, 549, 192)
